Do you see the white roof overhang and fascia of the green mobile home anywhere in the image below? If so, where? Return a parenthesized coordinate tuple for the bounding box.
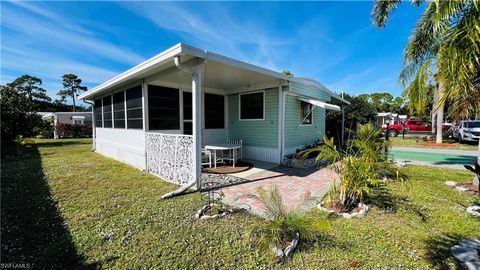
(79, 43, 349, 104)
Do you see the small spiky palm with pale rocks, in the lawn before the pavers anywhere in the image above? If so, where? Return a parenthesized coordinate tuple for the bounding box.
(246, 186, 329, 257)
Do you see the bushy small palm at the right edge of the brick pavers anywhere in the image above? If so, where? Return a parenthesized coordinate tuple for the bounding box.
(302, 124, 406, 210)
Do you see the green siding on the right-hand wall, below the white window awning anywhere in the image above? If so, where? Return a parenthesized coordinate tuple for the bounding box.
(285, 95, 325, 149)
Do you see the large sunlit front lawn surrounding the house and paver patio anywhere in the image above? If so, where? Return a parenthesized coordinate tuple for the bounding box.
(1, 139, 480, 269)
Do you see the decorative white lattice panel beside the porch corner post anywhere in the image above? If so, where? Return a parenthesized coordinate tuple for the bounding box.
(145, 133, 194, 185)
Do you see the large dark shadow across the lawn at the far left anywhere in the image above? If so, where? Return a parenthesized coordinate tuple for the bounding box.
(1, 144, 96, 269)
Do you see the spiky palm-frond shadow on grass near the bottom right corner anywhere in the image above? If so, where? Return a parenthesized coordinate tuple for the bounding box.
(425, 233, 466, 270)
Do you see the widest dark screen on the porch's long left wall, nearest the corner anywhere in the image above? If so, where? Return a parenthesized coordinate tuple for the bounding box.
(125, 85, 143, 129)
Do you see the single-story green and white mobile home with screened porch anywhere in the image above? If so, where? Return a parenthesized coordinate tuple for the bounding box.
(79, 44, 348, 189)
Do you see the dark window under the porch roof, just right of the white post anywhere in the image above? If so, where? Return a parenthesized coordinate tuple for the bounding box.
(205, 94, 224, 128)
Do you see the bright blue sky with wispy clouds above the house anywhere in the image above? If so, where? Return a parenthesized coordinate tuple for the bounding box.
(0, 1, 422, 103)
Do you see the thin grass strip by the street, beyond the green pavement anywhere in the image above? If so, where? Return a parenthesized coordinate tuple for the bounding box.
(389, 135, 478, 151)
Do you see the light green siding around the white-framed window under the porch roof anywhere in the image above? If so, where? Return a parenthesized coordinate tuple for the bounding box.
(228, 88, 279, 148)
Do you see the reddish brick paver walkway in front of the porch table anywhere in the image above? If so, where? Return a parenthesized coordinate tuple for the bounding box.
(221, 167, 338, 215)
